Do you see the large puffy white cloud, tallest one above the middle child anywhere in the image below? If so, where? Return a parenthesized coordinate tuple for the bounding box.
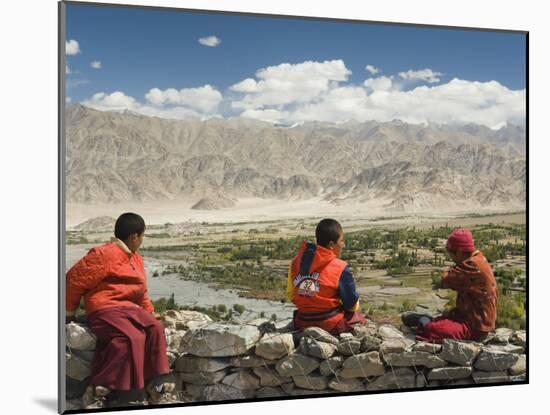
(230, 59, 351, 110)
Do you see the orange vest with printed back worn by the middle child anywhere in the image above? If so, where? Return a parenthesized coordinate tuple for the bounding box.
(291, 241, 347, 331)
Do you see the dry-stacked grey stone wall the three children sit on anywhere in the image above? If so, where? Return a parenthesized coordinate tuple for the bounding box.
(66, 310, 526, 409)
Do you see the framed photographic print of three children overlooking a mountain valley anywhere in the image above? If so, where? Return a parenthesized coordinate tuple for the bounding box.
(59, 1, 528, 413)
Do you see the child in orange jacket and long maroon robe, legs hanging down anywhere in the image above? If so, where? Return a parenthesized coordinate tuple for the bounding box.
(66, 213, 175, 408)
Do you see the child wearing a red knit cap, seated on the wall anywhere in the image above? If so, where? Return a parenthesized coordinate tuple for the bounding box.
(401, 229, 498, 342)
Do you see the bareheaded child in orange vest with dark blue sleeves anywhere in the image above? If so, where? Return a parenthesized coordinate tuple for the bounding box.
(287, 219, 366, 335)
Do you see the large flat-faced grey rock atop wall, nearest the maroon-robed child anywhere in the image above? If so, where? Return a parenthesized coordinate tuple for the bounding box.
(180, 323, 260, 357)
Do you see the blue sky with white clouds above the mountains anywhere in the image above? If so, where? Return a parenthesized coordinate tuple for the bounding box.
(65, 4, 526, 129)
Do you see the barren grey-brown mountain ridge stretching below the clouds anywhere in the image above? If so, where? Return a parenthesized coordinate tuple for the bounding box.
(66, 104, 526, 211)
